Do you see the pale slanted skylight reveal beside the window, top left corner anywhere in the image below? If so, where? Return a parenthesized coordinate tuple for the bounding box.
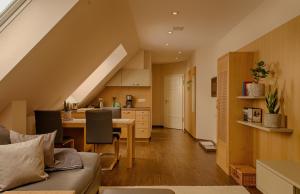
(0, 0, 78, 81)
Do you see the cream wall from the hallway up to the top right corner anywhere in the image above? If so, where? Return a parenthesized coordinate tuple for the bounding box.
(192, 0, 300, 141)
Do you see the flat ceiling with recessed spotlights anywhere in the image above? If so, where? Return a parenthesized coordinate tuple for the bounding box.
(129, 0, 263, 63)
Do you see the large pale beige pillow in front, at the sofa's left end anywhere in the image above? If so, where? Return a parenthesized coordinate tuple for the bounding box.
(0, 137, 48, 192)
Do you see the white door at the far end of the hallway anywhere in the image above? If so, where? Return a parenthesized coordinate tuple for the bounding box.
(164, 74, 184, 129)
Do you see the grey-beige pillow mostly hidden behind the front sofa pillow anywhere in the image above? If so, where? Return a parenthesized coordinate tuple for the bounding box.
(10, 130, 56, 168)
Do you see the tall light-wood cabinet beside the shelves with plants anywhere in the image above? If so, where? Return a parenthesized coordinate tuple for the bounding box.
(217, 52, 254, 174)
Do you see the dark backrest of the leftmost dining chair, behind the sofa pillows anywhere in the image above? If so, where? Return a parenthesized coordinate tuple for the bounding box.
(34, 110, 63, 144)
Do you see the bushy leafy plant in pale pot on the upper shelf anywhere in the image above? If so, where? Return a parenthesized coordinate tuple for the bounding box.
(247, 61, 270, 96)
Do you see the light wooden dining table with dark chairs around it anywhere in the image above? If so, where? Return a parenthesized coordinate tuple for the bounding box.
(62, 118, 135, 168)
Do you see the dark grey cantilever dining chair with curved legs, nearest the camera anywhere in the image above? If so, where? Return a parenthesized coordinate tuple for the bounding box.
(85, 110, 120, 170)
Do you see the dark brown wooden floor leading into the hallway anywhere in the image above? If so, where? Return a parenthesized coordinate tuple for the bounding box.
(101, 128, 256, 193)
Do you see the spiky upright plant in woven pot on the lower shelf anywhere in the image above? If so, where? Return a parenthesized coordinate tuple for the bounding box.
(263, 88, 281, 128)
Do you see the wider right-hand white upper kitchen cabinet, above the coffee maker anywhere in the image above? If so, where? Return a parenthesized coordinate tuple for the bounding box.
(122, 69, 151, 86)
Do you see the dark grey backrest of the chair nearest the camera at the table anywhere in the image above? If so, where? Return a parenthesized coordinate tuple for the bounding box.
(85, 110, 113, 144)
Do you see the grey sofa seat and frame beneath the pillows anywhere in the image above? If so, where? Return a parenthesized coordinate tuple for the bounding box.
(0, 126, 101, 194)
